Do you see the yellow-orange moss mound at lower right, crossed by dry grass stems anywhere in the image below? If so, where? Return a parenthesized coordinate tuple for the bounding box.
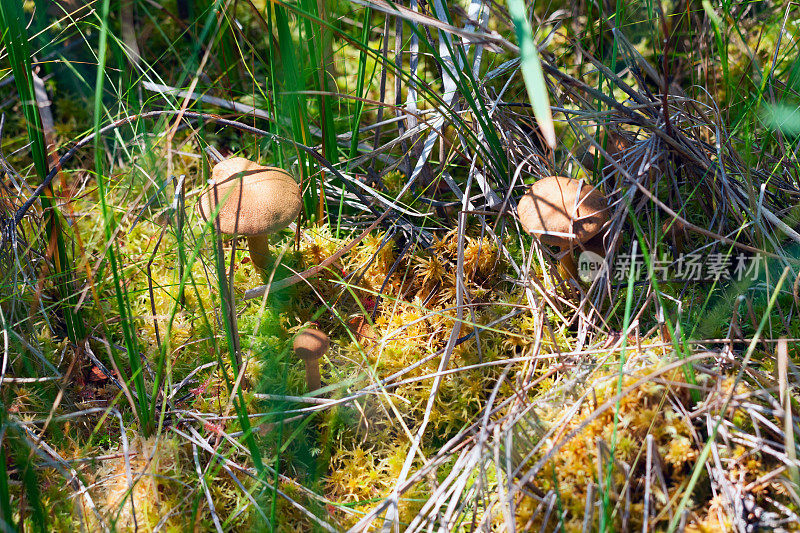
(517, 352, 788, 531)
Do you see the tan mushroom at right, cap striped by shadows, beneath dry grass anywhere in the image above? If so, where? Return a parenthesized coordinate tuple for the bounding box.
(517, 176, 609, 280)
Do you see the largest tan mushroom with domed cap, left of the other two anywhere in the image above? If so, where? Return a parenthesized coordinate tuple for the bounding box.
(199, 157, 302, 271)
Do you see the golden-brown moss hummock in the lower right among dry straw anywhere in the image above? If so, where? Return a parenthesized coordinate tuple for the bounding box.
(510, 348, 774, 532)
